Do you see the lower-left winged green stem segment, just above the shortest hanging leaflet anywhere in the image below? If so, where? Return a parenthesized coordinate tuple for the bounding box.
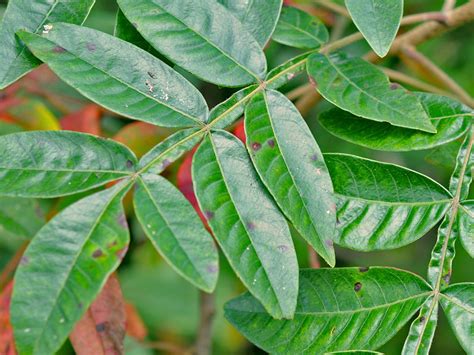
(138, 128, 204, 174)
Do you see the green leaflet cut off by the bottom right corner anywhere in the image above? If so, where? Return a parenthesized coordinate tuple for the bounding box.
(439, 282, 474, 354)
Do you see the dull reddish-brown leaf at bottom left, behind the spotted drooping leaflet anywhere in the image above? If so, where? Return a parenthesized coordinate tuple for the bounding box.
(69, 274, 125, 355)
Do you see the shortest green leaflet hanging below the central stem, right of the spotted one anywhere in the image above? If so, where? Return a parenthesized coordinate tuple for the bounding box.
(133, 174, 219, 292)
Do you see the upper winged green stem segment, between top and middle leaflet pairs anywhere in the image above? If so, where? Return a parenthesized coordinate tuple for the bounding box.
(209, 85, 259, 129)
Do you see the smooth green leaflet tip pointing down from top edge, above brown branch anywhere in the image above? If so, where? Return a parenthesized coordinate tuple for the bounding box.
(345, 0, 403, 57)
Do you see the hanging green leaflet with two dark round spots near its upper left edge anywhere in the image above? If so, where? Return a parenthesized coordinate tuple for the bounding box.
(245, 91, 336, 266)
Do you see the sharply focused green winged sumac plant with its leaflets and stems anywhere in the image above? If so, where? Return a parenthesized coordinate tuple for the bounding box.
(0, 0, 474, 354)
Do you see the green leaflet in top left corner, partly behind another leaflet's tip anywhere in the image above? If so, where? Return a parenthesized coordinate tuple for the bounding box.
(0, 0, 95, 89)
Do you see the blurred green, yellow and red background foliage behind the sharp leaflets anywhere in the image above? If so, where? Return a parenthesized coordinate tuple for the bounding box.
(0, 0, 474, 355)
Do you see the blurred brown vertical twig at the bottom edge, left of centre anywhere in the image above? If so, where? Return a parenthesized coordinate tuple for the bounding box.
(196, 291, 215, 355)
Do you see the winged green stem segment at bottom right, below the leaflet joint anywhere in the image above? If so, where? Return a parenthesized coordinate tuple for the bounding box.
(402, 296, 438, 355)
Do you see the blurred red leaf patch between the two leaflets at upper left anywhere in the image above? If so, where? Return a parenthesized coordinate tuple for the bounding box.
(61, 105, 101, 136)
